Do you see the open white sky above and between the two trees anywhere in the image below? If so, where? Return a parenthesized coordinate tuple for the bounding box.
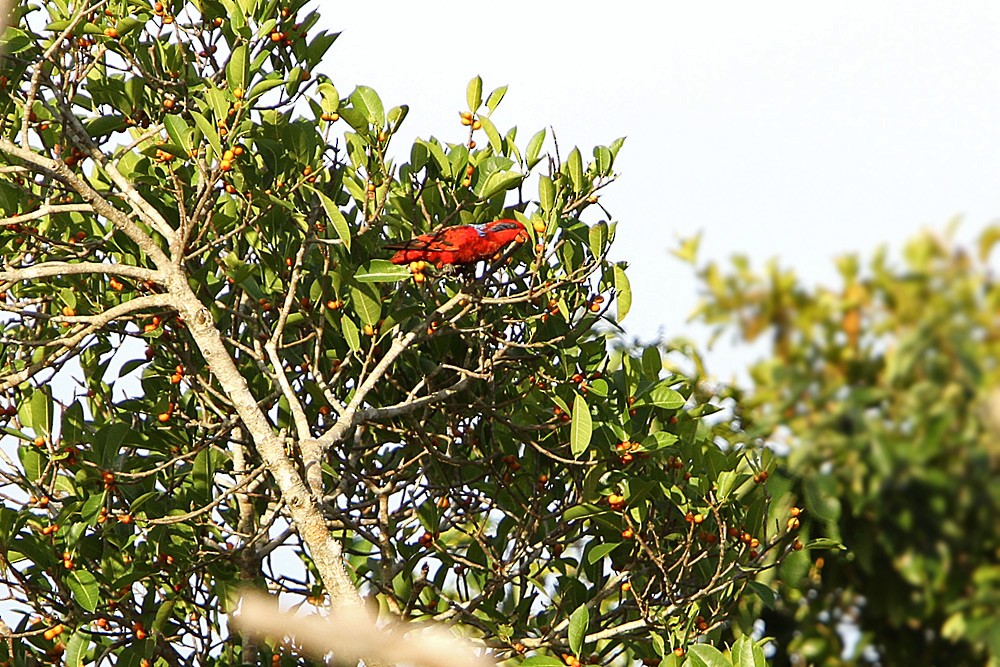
(320, 0, 1000, 375)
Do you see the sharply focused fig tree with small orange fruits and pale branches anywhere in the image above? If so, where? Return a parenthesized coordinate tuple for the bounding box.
(0, 0, 802, 665)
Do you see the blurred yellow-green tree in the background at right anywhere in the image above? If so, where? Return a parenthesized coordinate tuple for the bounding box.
(687, 227, 1000, 665)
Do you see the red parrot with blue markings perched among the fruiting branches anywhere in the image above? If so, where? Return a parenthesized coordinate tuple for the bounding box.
(385, 218, 528, 268)
